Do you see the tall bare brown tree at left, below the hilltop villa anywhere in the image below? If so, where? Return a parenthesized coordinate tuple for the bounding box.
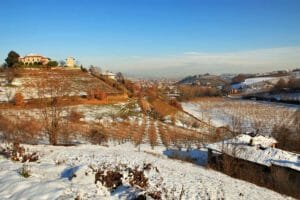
(36, 71, 70, 145)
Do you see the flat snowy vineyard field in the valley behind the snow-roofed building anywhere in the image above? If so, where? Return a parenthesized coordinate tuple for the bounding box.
(182, 98, 300, 135)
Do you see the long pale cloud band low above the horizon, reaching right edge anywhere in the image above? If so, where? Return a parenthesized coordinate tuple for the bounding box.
(81, 47, 300, 77)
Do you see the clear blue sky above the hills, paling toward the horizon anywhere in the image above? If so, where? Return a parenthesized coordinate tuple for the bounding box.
(0, 0, 300, 76)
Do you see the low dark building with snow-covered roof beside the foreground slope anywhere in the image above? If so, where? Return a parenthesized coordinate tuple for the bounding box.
(207, 134, 300, 198)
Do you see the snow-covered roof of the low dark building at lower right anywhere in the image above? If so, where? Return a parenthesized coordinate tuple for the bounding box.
(207, 135, 300, 171)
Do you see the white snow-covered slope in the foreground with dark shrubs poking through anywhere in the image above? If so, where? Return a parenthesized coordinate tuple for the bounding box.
(0, 143, 289, 200)
